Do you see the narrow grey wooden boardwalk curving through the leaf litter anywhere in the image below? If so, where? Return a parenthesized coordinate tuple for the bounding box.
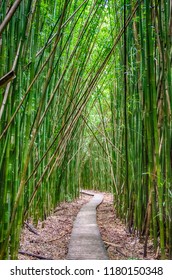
(67, 194, 108, 260)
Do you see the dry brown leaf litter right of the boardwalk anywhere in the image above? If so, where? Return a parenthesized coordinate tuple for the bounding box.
(97, 193, 155, 260)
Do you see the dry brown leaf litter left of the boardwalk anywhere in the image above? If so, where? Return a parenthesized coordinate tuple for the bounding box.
(18, 195, 90, 260)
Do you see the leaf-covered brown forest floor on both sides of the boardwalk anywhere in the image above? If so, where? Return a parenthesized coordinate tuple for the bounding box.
(18, 193, 156, 260)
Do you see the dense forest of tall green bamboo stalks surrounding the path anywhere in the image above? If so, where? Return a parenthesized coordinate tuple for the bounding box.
(0, 0, 172, 259)
